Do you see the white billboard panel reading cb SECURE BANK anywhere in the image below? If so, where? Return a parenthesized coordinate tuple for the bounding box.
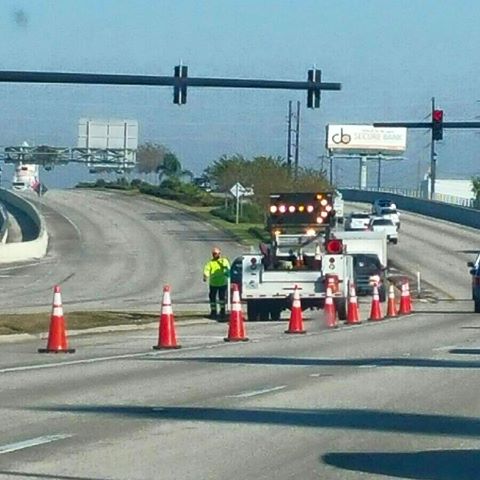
(327, 125, 407, 155)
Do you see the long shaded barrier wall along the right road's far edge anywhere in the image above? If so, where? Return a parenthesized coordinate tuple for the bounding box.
(340, 189, 480, 228)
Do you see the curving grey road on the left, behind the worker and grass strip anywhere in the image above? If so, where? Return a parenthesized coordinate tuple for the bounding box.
(0, 190, 242, 312)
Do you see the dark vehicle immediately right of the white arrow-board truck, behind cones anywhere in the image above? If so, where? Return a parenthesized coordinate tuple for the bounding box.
(352, 253, 387, 302)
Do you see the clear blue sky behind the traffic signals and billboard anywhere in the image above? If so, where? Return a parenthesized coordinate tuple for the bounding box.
(0, 0, 480, 187)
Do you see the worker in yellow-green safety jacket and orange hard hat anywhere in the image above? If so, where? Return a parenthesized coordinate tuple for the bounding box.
(203, 247, 230, 320)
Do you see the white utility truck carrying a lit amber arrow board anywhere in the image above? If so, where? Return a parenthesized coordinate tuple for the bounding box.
(232, 192, 354, 321)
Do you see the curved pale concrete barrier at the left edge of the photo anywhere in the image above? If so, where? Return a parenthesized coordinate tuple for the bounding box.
(0, 189, 48, 263)
